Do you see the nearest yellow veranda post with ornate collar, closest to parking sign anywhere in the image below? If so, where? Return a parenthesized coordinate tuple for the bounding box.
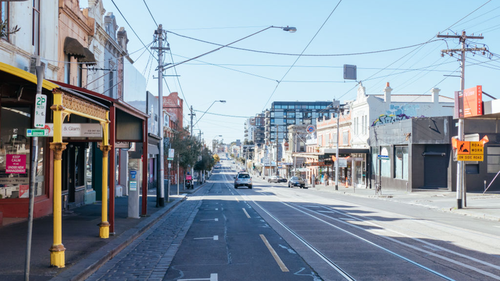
(49, 90, 67, 268)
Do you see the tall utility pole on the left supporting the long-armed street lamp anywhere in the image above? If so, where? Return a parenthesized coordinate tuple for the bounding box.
(151, 24, 170, 207)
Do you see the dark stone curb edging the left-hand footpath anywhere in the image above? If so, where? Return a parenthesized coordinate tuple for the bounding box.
(50, 194, 186, 281)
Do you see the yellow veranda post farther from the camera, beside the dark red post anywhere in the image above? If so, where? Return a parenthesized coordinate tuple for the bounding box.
(99, 111, 111, 238)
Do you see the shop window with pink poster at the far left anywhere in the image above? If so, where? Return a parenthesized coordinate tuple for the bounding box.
(0, 106, 45, 199)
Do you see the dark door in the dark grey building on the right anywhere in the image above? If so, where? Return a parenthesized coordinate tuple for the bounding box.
(424, 144, 448, 188)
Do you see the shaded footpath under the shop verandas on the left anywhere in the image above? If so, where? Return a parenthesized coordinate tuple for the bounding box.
(0, 184, 203, 281)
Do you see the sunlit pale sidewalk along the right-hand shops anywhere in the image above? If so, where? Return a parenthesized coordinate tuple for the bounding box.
(309, 185, 500, 221)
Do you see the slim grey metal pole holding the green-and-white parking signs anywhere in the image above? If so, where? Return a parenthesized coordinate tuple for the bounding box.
(24, 64, 45, 281)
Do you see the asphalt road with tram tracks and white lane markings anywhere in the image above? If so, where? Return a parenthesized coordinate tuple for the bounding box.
(88, 161, 500, 280)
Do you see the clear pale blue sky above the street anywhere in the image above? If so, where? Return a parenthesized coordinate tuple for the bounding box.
(80, 0, 500, 143)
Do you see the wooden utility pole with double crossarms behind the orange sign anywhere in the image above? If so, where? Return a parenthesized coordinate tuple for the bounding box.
(437, 31, 487, 209)
